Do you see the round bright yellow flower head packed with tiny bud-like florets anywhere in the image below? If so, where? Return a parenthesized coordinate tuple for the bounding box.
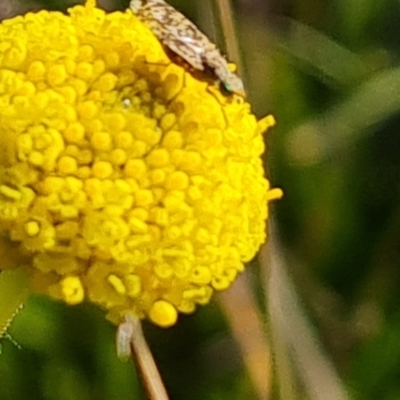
(0, 1, 281, 327)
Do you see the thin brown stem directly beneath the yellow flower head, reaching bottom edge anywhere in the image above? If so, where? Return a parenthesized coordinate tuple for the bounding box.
(129, 316, 169, 400)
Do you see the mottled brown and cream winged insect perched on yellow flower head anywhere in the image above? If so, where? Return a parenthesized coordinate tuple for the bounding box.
(129, 0, 245, 96)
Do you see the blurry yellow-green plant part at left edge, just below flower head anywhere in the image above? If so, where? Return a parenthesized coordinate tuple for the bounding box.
(0, 268, 30, 339)
